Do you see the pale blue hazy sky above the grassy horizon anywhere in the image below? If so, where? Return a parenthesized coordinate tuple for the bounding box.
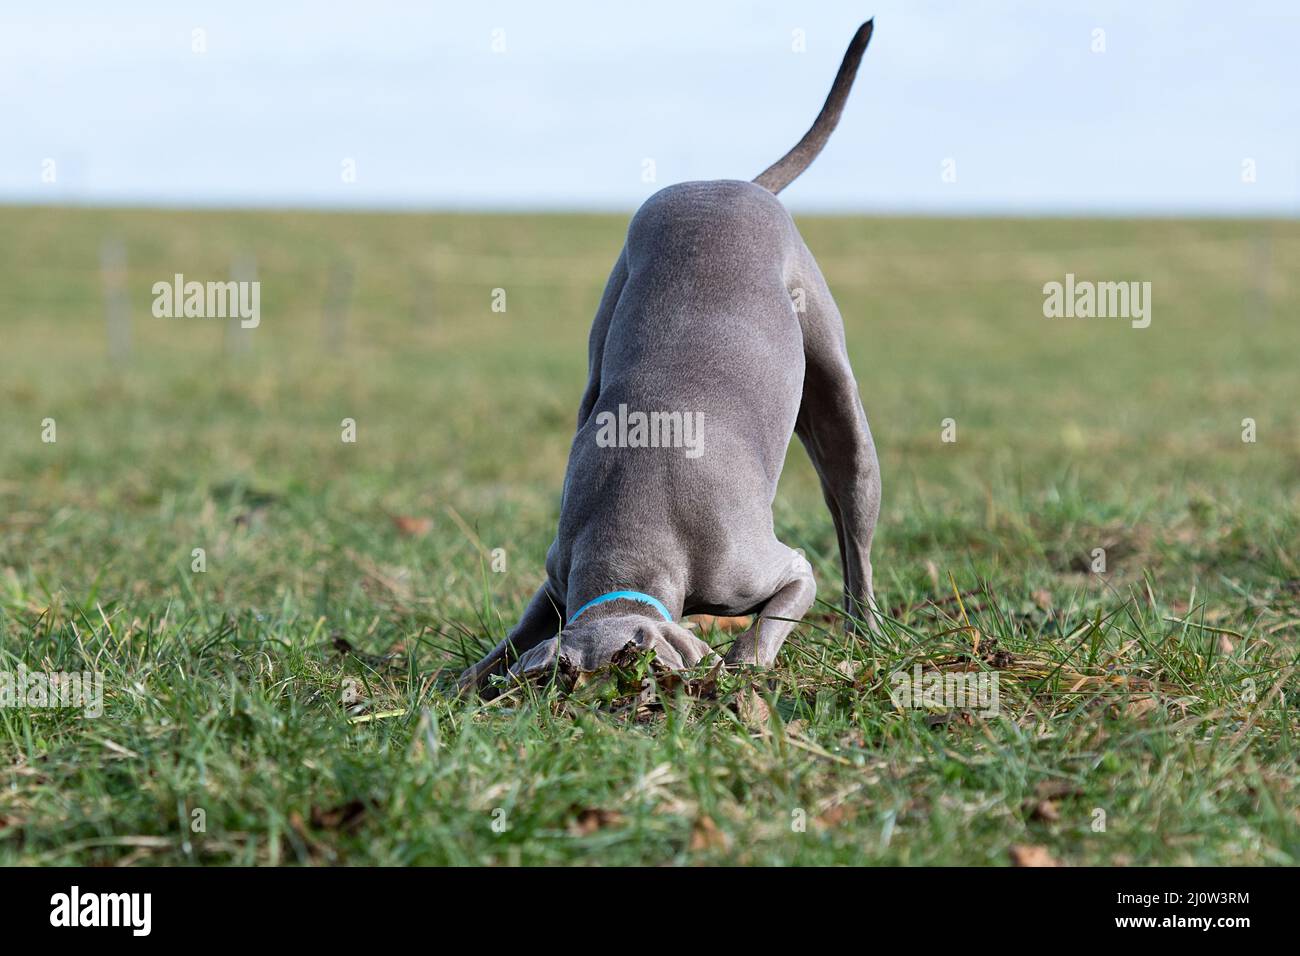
(0, 0, 1300, 216)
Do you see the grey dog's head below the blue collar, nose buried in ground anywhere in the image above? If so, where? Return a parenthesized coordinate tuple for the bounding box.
(510, 614, 716, 676)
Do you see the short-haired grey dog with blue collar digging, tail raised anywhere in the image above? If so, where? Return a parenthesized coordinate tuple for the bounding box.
(460, 16, 880, 688)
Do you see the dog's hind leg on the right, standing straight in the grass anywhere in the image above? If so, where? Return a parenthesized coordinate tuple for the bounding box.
(789, 247, 880, 630)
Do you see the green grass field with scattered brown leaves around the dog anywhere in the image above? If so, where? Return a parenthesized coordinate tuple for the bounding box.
(0, 208, 1300, 865)
